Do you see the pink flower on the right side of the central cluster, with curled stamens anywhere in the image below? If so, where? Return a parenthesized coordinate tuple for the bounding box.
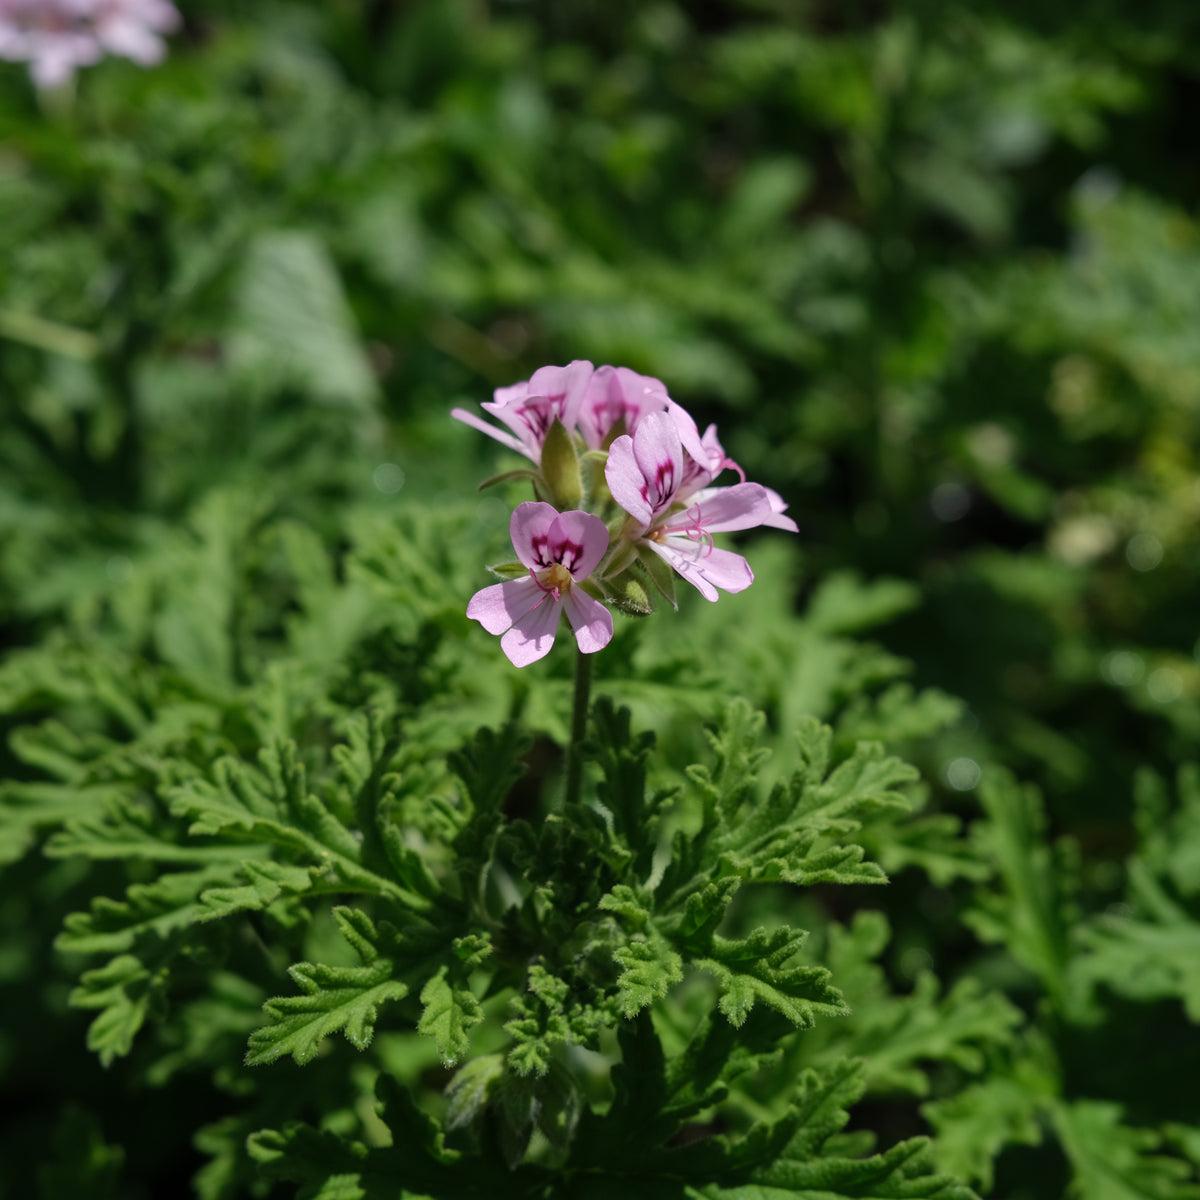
(605, 412, 796, 600)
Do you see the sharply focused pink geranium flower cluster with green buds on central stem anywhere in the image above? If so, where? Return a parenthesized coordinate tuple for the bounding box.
(451, 361, 796, 667)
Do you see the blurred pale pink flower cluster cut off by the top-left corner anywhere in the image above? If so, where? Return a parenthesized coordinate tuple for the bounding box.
(0, 0, 179, 88)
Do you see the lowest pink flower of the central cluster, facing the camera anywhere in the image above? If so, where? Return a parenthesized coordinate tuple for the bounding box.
(467, 500, 612, 667)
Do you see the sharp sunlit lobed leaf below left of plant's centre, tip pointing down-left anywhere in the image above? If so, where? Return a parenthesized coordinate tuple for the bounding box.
(246, 908, 408, 1067)
